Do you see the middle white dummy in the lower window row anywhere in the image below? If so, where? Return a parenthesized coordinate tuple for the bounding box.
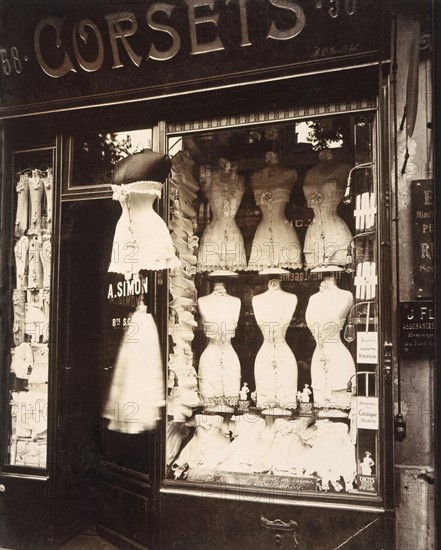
(252, 279, 297, 415)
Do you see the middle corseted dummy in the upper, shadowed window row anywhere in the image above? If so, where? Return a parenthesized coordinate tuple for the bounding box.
(248, 152, 302, 271)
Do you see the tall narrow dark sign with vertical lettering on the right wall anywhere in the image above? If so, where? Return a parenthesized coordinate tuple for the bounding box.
(411, 179, 434, 299)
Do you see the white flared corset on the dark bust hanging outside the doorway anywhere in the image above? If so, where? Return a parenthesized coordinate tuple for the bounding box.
(109, 181, 180, 278)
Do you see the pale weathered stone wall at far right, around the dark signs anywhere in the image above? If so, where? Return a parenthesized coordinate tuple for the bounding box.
(391, 1, 435, 550)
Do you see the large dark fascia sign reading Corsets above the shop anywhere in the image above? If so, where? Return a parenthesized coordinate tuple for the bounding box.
(0, 0, 388, 113)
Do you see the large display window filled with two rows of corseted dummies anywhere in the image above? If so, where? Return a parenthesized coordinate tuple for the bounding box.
(166, 115, 379, 495)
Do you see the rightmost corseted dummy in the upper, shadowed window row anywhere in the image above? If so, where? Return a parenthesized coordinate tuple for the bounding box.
(303, 149, 352, 269)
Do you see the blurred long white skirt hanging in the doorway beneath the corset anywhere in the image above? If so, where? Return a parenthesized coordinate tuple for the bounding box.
(103, 306, 165, 434)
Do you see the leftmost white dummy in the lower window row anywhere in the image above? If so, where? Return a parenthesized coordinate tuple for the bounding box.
(198, 283, 241, 412)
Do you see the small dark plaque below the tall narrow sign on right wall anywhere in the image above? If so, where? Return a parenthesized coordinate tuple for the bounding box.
(399, 301, 435, 359)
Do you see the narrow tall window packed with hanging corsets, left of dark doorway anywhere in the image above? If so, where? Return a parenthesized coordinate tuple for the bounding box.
(7, 149, 54, 468)
